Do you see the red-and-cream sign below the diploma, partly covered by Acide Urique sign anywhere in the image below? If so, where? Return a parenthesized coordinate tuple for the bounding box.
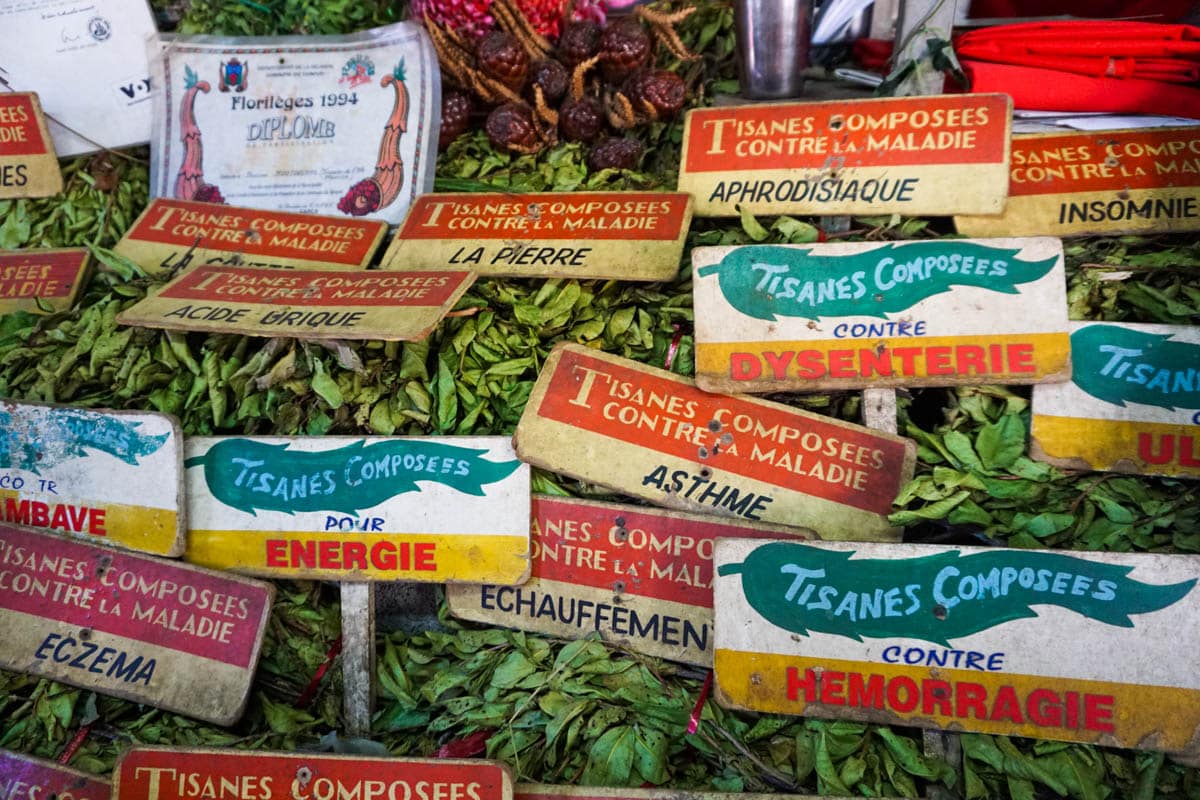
(113, 198, 388, 275)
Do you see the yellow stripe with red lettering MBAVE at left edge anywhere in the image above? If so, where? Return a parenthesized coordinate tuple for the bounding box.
(0, 491, 184, 557)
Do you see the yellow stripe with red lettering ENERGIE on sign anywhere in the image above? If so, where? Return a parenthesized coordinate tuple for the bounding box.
(184, 530, 529, 584)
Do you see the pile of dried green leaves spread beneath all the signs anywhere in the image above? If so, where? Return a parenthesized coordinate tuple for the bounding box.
(0, 0, 1200, 799)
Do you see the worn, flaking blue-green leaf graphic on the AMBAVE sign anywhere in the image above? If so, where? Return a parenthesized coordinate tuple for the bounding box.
(0, 409, 169, 475)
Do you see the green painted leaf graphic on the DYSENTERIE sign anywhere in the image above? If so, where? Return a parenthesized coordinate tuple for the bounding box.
(698, 241, 1058, 320)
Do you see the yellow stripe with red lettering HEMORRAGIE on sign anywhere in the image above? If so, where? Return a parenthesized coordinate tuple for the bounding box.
(714, 648, 1200, 751)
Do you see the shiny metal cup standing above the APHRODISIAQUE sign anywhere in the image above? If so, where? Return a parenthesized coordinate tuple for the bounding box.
(733, 0, 812, 100)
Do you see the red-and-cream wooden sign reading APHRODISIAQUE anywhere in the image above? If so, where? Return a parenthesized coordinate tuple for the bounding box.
(679, 95, 1012, 217)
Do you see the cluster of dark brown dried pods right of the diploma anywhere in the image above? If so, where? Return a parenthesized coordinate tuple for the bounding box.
(427, 0, 700, 169)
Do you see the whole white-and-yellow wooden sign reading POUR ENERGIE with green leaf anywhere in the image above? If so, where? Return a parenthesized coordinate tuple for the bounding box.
(186, 437, 529, 584)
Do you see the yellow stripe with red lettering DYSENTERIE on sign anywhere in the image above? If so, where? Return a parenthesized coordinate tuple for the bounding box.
(696, 331, 1070, 386)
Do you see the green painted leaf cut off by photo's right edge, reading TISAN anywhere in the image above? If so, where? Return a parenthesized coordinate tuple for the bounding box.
(1070, 325, 1200, 410)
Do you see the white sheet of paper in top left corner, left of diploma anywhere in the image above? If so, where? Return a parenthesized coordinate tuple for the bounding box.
(0, 0, 156, 157)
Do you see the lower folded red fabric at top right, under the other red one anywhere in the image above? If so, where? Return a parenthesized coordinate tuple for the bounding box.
(962, 60, 1200, 118)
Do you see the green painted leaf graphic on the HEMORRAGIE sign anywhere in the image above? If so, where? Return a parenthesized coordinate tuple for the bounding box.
(718, 542, 1196, 646)
